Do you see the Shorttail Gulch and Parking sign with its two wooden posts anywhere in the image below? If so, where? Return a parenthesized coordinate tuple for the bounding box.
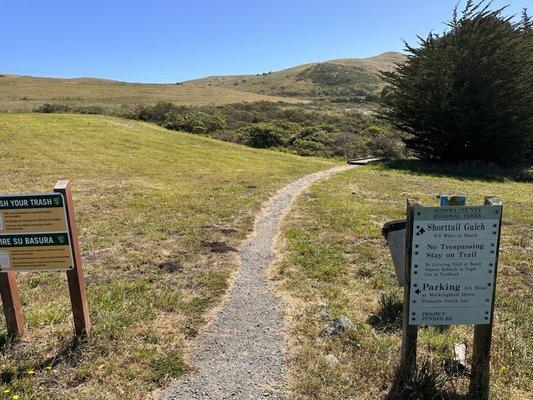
(401, 197, 502, 400)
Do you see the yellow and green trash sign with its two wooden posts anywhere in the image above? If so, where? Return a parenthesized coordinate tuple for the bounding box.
(0, 181, 91, 336)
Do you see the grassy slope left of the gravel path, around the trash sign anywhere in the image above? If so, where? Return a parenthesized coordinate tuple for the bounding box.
(0, 114, 332, 400)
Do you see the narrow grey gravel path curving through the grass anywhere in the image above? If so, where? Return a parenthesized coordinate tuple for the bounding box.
(162, 166, 352, 400)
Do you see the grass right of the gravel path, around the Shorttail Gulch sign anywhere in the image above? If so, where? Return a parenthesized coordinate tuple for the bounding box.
(273, 162, 533, 400)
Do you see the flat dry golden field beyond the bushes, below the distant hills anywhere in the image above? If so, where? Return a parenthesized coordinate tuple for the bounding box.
(0, 75, 304, 111)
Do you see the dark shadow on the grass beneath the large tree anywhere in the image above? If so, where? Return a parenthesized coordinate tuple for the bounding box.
(380, 159, 533, 182)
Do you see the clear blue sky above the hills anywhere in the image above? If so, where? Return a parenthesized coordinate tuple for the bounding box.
(0, 0, 533, 82)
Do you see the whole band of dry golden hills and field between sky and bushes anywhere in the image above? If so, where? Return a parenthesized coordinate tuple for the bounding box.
(0, 52, 405, 111)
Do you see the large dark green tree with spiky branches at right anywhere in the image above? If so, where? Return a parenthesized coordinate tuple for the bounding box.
(381, 0, 533, 164)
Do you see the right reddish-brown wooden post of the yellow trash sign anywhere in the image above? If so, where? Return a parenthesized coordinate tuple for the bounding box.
(54, 181, 91, 336)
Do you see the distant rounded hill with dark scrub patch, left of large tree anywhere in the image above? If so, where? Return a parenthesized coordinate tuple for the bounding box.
(184, 52, 405, 97)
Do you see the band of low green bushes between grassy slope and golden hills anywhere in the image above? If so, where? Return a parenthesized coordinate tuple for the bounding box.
(34, 101, 405, 158)
